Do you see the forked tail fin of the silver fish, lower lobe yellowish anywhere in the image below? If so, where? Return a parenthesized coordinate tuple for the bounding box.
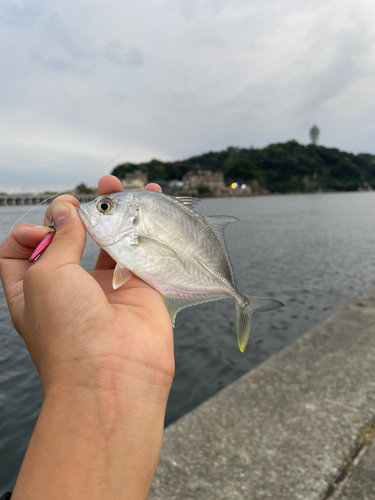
(236, 295, 284, 352)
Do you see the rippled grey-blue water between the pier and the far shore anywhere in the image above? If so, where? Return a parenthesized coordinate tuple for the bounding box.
(0, 192, 375, 493)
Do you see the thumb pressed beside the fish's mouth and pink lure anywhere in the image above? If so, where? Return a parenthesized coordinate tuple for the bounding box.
(41, 202, 86, 266)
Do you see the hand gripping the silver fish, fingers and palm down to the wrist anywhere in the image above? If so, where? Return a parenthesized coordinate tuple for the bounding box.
(0, 176, 174, 397)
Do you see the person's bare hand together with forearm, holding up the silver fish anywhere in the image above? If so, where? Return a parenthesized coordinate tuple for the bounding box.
(0, 176, 174, 500)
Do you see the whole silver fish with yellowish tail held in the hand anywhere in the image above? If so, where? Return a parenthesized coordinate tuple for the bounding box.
(78, 190, 283, 352)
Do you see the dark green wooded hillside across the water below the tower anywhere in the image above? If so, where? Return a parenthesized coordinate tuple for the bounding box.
(112, 141, 375, 193)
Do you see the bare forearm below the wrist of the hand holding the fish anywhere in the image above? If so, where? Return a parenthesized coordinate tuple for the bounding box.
(12, 378, 166, 500)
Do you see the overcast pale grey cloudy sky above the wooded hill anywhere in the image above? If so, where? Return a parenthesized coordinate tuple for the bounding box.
(0, 0, 375, 191)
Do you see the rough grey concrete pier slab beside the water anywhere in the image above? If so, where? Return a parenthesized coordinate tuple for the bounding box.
(149, 289, 375, 500)
